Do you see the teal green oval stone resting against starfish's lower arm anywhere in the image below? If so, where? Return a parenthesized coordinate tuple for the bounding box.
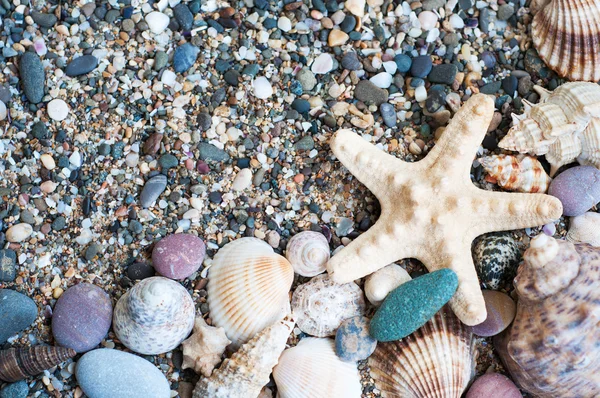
(371, 268, 458, 341)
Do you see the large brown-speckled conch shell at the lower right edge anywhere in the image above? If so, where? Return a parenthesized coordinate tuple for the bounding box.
(495, 234, 600, 398)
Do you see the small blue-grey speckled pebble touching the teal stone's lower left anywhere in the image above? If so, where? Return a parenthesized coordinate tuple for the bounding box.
(335, 315, 377, 362)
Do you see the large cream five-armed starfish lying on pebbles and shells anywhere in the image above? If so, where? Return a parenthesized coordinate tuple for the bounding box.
(327, 94, 562, 325)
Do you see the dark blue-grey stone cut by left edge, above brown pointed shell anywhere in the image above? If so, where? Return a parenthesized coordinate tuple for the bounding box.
(0, 289, 37, 344)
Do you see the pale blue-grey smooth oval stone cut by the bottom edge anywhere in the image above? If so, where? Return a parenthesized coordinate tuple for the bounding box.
(75, 348, 171, 398)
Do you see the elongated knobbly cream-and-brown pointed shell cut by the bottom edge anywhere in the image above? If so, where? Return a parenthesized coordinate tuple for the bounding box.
(193, 319, 294, 398)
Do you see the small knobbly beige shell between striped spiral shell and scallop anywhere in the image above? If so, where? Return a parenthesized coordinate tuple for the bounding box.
(181, 316, 231, 377)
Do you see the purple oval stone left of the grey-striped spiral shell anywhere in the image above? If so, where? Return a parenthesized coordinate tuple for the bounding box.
(52, 283, 112, 352)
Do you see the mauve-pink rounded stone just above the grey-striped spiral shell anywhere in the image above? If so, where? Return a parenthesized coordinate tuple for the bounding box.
(152, 234, 206, 279)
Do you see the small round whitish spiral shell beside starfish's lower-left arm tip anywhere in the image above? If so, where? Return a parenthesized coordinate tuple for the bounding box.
(285, 231, 329, 277)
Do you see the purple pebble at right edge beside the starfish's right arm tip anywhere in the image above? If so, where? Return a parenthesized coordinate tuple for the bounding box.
(548, 166, 600, 217)
